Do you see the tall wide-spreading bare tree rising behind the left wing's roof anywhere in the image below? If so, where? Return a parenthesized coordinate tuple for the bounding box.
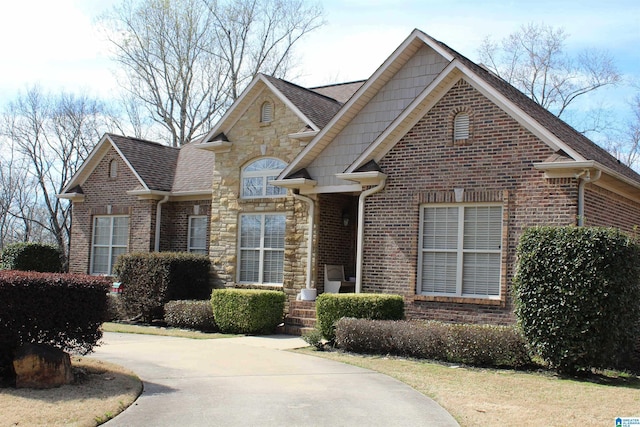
(102, 0, 322, 146)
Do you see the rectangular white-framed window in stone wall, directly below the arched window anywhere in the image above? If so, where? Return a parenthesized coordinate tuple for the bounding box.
(238, 214, 285, 284)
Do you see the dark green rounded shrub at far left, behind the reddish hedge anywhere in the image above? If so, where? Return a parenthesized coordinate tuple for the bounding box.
(0, 242, 62, 273)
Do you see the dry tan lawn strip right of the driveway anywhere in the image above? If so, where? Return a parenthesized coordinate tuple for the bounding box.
(302, 349, 640, 426)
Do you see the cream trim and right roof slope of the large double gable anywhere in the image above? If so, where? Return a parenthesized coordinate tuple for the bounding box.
(279, 30, 640, 190)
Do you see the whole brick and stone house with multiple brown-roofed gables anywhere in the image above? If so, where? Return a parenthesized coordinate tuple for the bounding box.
(62, 30, 640, 323)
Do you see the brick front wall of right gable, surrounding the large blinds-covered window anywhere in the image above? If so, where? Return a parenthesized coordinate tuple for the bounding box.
(363, 80, 578, 323)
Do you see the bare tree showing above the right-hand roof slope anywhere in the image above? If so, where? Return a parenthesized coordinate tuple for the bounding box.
(479, 24, 621, 127)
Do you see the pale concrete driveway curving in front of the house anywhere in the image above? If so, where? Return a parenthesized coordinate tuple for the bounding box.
(93, 332, 458, 427)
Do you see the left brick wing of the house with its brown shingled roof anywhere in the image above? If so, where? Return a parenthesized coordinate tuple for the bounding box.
(58, 134, 214, 275)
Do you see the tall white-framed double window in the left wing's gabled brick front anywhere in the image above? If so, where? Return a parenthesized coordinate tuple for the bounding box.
(91, 215, 129, 275)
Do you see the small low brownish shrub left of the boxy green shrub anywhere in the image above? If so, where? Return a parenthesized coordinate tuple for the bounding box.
(164, 300, 217, 332)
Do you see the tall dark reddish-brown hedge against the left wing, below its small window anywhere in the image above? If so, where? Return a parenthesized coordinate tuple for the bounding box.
(114, 252, 211, 322)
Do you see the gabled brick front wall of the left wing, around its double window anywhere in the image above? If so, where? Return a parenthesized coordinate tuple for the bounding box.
(69, 148, 156, 273)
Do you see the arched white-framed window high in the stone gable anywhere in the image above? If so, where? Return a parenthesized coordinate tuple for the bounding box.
(242, 159, 287, 199)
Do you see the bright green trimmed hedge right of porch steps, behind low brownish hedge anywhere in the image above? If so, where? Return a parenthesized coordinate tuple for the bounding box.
(316, 293, 404, 341)
